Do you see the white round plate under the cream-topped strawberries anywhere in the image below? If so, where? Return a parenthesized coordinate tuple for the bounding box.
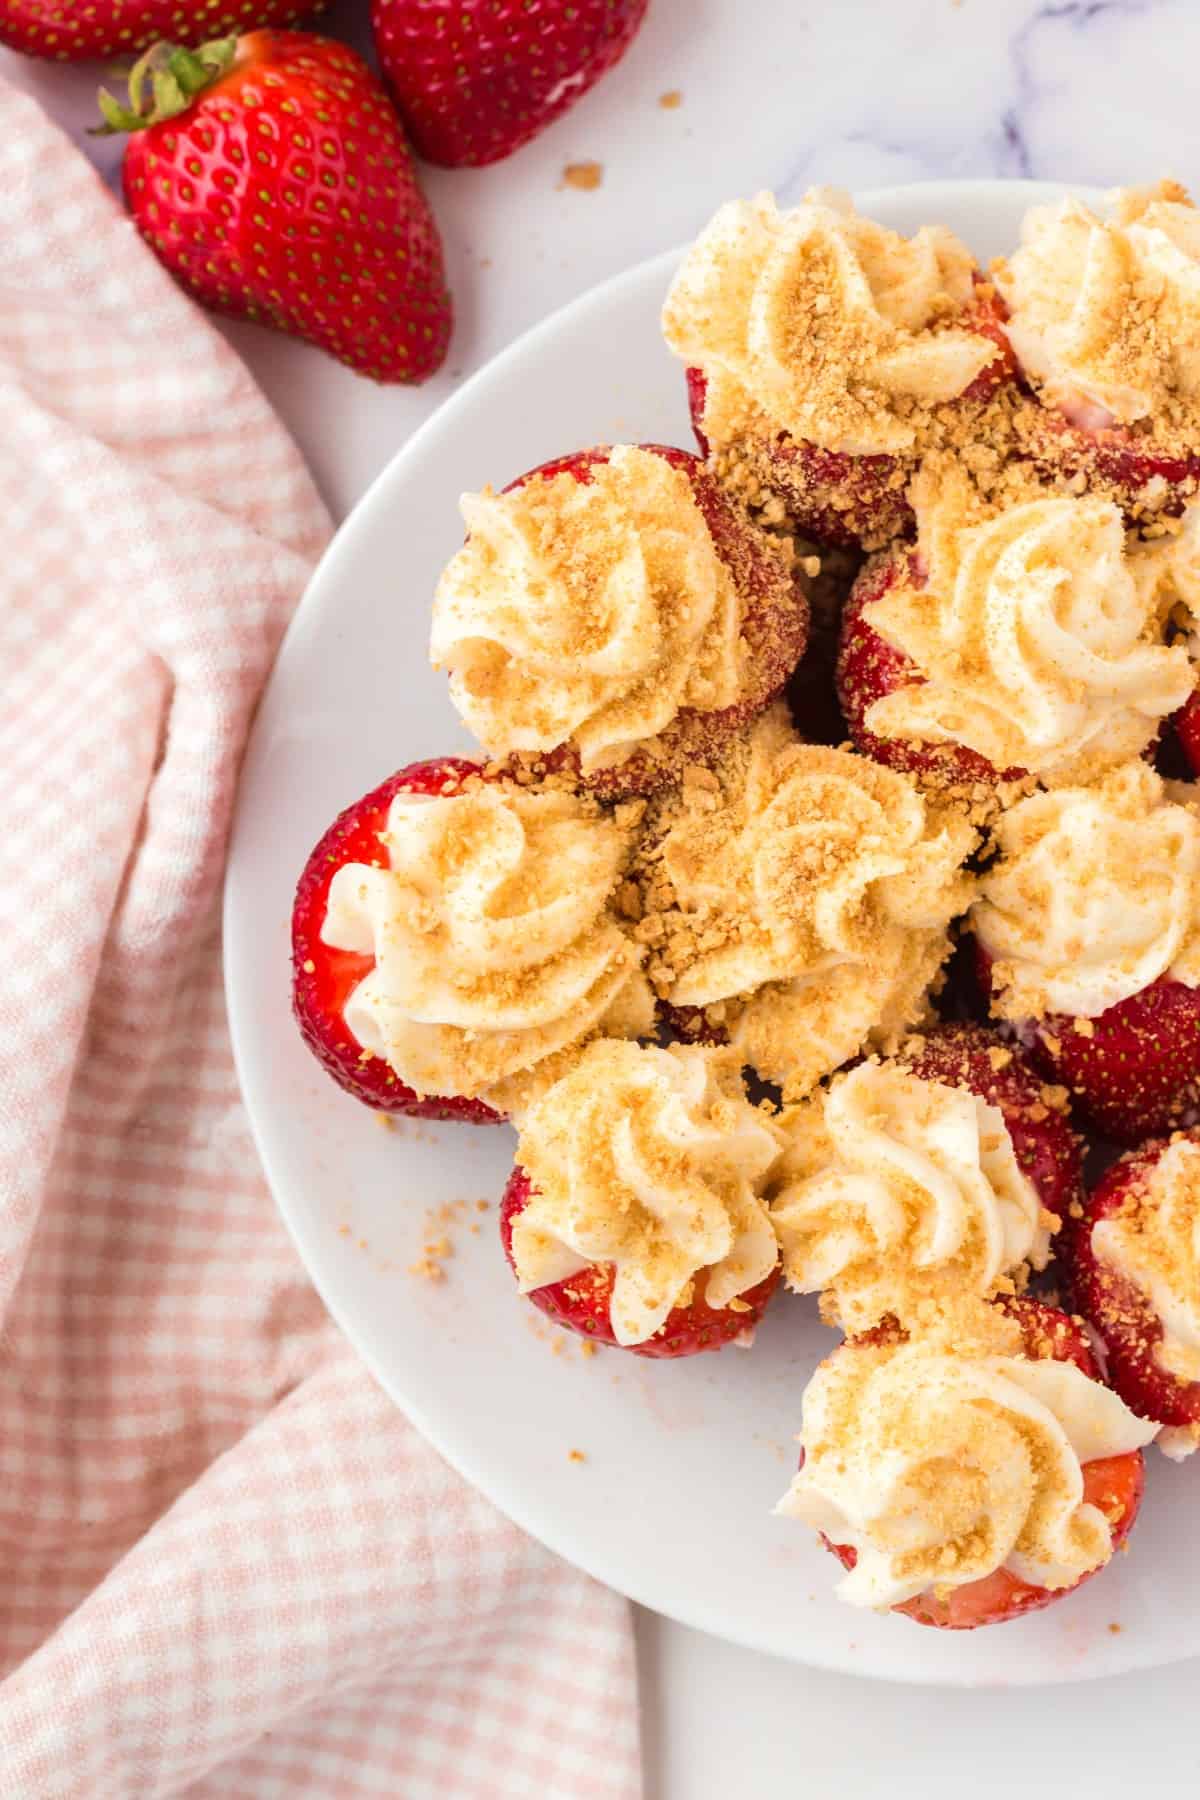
(225, 182, 1200, 1685)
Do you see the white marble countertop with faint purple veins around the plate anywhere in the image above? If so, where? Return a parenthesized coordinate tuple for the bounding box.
(0, 0, 1200, 1800)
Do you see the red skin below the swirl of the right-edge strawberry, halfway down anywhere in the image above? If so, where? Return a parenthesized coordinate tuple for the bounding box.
(975, 945, 1200, 1145)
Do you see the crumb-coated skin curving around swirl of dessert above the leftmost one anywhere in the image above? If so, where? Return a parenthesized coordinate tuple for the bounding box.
(492, 445, 810, 801)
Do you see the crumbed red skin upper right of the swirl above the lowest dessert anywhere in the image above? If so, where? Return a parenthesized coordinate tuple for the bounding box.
(900, 1024, 1083, 1220)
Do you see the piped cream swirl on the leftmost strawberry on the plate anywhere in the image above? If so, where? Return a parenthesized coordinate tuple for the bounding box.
(322, 779, 651, 1096)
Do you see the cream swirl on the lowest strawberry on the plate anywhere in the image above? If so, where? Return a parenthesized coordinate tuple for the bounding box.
(777, 1339, 1157, 1607)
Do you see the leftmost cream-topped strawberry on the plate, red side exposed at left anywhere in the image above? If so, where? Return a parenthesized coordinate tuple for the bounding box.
(291, 758, 653, 1123)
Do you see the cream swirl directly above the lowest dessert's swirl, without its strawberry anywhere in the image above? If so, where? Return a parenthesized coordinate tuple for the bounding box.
(770, 1062, 1051, 1332)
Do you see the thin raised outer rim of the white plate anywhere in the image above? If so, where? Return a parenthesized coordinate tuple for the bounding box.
(221, 176, 1173, 1690)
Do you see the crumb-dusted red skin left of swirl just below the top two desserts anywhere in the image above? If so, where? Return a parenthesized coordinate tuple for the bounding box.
(837, 547, 1024, 787)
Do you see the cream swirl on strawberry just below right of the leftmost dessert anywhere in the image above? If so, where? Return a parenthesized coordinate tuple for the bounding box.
(513, 1039, 783, 1345)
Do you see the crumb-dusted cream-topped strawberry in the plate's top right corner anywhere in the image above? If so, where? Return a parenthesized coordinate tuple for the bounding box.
(991, 182, 1200, 524)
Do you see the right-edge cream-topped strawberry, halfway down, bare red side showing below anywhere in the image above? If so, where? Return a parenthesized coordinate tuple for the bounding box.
(970, 761, 1200, 1143)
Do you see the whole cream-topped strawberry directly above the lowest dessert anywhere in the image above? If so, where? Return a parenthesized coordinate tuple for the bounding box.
(768, 1026, 1083, 1336)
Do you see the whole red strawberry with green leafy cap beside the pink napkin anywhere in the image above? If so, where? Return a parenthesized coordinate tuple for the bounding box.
(101, 31, 453, 382)
